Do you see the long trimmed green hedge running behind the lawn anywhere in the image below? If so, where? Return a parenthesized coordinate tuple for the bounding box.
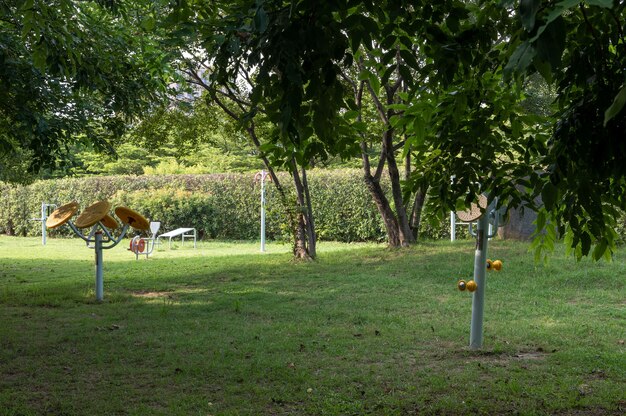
(0, 169, 449, 242)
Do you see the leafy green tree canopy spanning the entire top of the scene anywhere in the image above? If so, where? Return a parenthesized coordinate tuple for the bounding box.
(0, 0, 626, 258)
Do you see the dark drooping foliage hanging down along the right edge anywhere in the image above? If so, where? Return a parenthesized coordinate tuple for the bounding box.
(507, 0, 626, 259)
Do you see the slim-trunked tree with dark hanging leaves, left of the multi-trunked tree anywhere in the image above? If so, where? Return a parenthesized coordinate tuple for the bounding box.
(161, 1, 358, 258)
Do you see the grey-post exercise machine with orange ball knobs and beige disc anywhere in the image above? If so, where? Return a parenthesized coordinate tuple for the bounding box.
(457, 195, 502, 350)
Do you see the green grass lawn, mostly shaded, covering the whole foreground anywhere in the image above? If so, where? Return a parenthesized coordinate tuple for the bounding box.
(0, 236, 626, 415)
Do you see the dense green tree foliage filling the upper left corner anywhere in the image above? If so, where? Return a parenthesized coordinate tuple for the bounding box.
(0, 0, 170, 179)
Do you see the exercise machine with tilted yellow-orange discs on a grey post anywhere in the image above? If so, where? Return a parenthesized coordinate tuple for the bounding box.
(46, 200, 149, 302)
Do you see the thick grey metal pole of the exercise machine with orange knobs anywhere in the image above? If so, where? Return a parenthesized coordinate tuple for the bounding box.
(470, 213, 491, 350)
